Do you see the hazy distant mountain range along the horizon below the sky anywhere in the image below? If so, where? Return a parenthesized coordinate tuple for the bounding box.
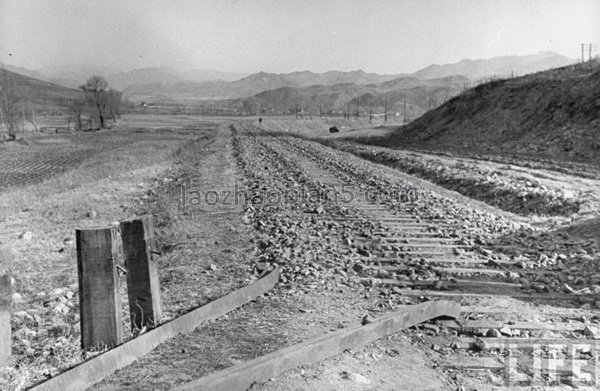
(0, 52, 576, 118)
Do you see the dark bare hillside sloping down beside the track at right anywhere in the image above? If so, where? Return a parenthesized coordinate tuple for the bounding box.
(379, 60, 600, 163)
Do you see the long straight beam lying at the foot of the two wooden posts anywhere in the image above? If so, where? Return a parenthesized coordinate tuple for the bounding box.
(31, 269, 279, 391)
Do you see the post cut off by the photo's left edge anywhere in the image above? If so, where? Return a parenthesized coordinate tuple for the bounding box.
(0, 246, 12, 367)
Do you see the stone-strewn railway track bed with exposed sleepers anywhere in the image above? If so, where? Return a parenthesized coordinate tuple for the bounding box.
(21, 122, 600, 390)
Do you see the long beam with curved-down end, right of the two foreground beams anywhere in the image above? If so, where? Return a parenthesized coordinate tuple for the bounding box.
(173, 301, 460, 391)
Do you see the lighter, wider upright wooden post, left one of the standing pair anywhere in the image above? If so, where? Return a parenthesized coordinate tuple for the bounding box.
(75, 228, 123, 350)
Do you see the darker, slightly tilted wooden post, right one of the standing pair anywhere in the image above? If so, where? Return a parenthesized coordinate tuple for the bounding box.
(121, 216, 162, 329)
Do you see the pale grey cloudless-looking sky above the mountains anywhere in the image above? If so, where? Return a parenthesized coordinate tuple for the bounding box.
(0, 0, 600, 73)
